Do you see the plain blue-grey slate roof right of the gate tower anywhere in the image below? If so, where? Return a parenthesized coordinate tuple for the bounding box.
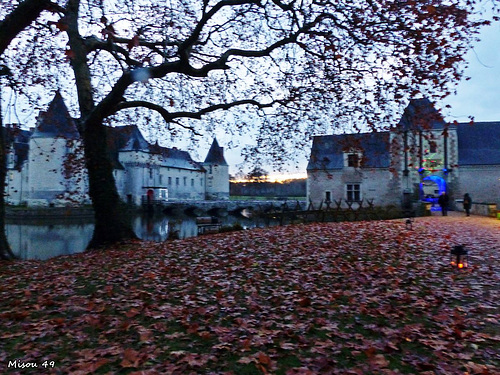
(457, 122, 500, 166)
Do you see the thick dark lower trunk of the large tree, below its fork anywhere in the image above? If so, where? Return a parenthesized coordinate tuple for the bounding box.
(83, 117, 136, 249)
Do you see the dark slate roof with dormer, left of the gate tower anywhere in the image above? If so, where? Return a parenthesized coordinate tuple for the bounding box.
(307, 132, 391, 170)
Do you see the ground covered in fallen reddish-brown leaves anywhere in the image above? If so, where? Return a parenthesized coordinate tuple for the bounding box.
(0, 216, 500, 374)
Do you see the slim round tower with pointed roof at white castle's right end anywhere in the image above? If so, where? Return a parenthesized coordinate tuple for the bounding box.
(203, 138, 229, 200)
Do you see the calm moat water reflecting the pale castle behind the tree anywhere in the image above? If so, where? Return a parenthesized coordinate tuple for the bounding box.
(5, 214, 275, 260)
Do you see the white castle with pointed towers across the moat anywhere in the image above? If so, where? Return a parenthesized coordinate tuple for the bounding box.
(5, 93, 229, 206)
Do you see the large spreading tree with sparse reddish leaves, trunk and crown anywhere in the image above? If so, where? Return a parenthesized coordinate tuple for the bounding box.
(0, 0, 492, 251)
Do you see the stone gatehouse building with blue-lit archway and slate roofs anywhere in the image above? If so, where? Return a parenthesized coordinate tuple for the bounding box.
(307, 99, 500, 210)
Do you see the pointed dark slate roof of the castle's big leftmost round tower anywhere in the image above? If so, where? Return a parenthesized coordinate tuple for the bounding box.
(32, 91, 80, 139)
